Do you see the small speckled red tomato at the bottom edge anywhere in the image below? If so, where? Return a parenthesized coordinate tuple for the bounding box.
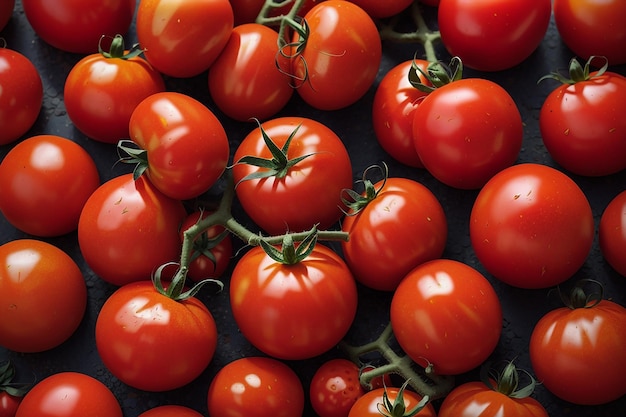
(309, 358, 365, 417)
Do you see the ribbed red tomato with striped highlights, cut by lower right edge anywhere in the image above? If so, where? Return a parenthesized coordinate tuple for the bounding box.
(530, 300, 626, 405)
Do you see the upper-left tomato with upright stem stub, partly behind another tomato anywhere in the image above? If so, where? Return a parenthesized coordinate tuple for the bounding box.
(63, 36, 165, 143)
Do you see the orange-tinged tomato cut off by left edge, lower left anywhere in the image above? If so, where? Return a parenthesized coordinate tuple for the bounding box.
(0, 239, 87, 352)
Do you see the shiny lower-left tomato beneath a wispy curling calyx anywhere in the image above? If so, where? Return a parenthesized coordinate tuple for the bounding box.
(96, 281, 217, 392)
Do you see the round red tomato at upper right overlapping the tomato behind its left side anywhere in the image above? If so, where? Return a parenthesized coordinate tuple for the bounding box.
(413, 78, 524, 189)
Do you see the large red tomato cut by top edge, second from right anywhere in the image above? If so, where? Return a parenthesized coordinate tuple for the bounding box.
(437, 0, 552, 71)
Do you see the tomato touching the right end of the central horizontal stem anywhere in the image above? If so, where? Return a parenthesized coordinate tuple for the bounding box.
(341, 178, 448, 291)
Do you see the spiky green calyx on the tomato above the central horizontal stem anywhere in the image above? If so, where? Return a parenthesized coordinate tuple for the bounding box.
(236, 120, 314, 183)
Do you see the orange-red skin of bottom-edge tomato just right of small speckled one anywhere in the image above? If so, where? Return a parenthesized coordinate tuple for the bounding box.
(348, 387, 437, 417)
